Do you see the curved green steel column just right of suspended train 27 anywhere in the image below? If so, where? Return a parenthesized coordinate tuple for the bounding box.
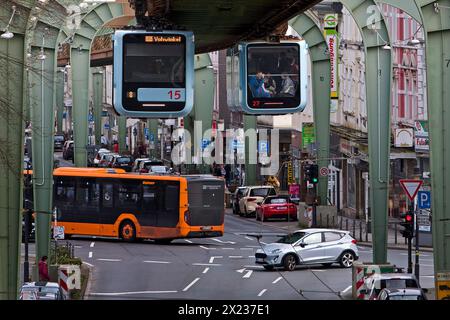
(289, 13, 331, 205)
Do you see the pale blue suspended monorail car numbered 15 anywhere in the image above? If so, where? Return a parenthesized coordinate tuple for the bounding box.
(113, 30, 194, 118)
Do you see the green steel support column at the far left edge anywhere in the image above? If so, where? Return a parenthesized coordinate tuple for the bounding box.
(0, 31, 26, 300)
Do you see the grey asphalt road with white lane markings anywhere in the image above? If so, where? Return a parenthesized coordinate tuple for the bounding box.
(47, 214, 433, 300)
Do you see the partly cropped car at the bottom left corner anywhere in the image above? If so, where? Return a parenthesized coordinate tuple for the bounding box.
(19, 281, 66, 300)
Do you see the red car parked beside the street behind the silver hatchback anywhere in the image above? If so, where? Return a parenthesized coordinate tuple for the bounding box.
(256, 196, 297, 221)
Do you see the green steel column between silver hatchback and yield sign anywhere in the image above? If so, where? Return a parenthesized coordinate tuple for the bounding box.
(341, 0, 392, 264)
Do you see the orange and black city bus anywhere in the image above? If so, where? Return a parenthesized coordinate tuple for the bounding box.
(33, 167, 225, 243)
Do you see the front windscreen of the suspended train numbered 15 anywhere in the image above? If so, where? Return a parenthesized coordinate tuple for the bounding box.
(123, 35, 186, 88)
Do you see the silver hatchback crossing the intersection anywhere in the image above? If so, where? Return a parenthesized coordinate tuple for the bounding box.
(255, 229, 358, 271)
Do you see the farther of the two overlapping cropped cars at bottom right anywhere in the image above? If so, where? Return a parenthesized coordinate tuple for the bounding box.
(360, 273, 420, 300)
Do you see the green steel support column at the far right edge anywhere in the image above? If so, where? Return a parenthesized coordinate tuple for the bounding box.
(416, 0, 450, 279)
